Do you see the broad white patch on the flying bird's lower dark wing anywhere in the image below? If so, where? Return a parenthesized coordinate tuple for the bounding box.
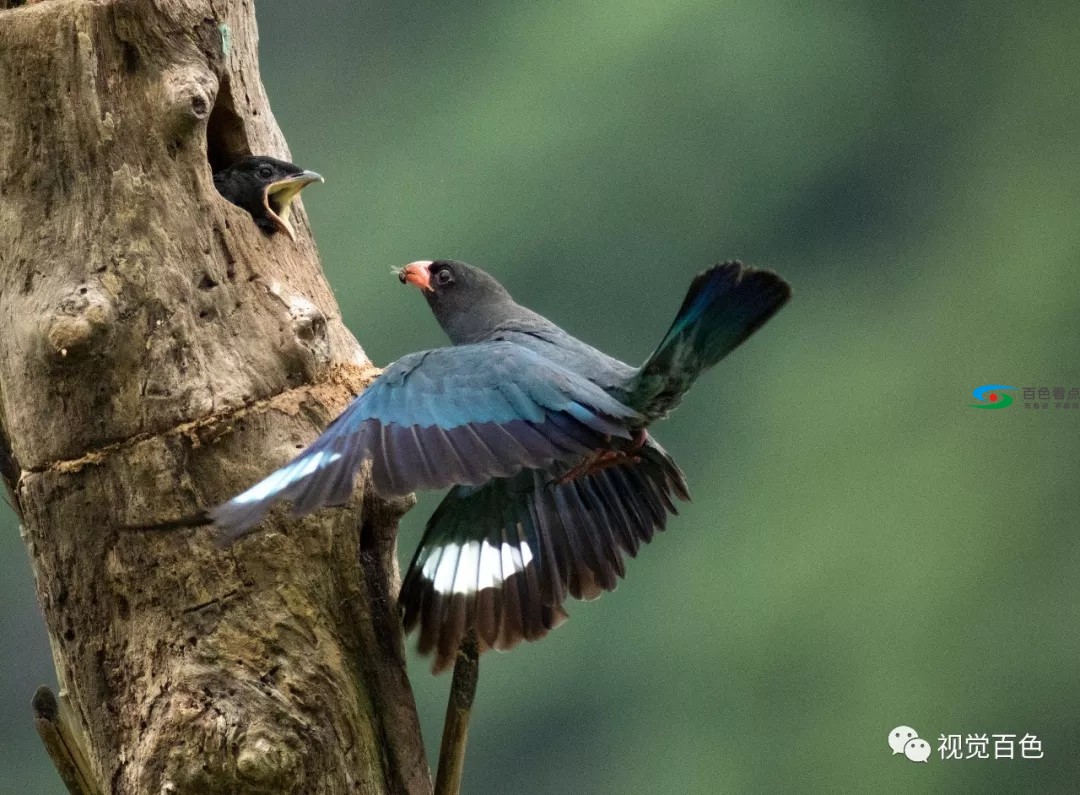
(420, 539, 532, 594)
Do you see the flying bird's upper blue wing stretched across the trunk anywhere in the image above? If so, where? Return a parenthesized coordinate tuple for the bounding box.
(207, 341, 639, 537)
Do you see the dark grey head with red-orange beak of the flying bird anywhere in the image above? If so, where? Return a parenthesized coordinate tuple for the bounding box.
(397, 259, 517, 343)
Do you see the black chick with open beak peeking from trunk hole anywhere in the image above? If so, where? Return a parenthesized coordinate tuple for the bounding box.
(214, 154, 324, 240)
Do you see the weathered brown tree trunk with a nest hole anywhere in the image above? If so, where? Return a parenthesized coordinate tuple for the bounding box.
(0, 0, 431, 794)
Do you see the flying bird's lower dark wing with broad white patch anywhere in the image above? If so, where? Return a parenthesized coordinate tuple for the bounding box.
(400, 436, 690, 673)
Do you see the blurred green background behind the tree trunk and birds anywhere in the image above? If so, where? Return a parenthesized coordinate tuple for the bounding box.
(0, 0, 1080, 795)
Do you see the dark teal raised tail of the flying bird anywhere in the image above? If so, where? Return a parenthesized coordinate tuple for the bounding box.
(627, 262, 792, 421)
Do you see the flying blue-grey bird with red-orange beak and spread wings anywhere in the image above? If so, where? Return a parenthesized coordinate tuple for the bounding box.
(206, 260, 791, 672)
